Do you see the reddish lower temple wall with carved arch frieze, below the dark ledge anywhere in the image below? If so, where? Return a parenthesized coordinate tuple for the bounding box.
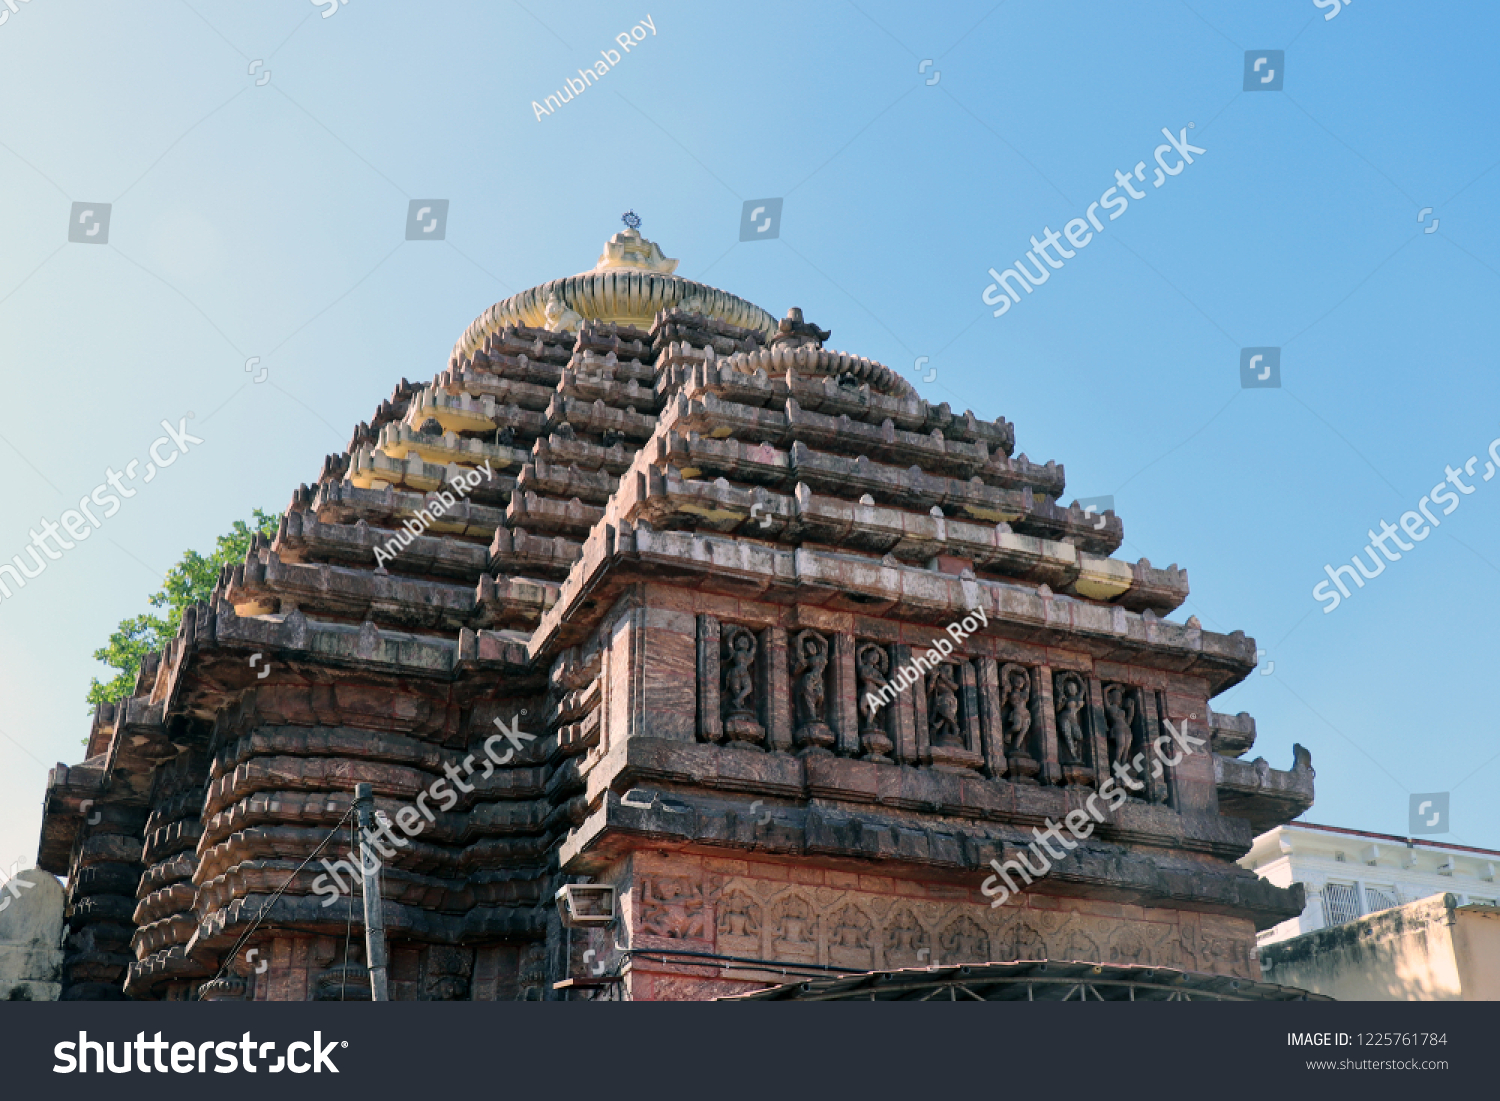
(569, 851, 1260, 999)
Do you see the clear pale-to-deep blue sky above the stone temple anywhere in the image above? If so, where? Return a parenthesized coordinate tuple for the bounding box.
(0, 0, 1500, 870)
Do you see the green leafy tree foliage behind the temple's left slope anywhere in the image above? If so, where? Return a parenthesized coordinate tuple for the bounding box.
(89, 509, 281, 711)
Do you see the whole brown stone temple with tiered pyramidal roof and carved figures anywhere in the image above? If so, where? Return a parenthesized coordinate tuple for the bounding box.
(38, 227, 1313, 1001)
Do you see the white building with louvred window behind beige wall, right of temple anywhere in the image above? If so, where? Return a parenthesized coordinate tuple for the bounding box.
(1239, 822, 1500, 945)
